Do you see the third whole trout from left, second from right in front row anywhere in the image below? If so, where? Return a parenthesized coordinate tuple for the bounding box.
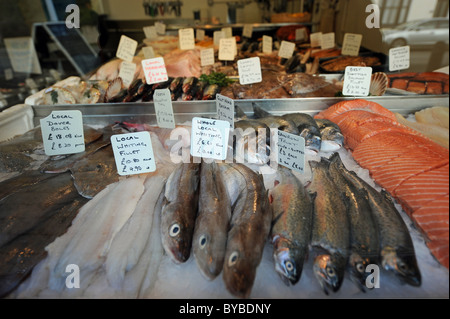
(329, 153, 380, 291)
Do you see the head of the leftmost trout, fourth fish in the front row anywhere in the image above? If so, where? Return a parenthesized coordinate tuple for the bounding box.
(273, 237, 304, 286)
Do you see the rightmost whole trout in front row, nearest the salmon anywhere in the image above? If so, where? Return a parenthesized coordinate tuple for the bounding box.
(344, 171, 421, 286)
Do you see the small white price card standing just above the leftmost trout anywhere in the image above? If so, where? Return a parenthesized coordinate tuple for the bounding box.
(278, 130, 305, 173)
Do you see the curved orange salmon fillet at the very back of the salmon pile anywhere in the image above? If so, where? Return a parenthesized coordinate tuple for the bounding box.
(314, 99, 395, 122)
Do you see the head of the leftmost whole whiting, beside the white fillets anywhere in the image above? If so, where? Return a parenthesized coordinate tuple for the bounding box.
(161, 203, 193, 263)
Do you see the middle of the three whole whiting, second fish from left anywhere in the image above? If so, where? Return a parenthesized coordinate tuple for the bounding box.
(192, 162, 231, 280)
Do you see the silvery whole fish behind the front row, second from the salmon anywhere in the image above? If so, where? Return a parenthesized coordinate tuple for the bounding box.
(282, 113, 322, 153)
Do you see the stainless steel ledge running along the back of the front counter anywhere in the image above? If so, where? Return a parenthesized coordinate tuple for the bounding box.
(32, 95, 449, 126)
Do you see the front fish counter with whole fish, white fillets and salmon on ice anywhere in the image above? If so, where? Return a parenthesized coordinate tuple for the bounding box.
(0, 95, 449, 299)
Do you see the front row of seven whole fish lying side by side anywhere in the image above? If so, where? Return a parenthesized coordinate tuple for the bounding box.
(155, 153, 421, 298)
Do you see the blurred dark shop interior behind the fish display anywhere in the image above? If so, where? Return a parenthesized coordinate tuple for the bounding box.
(0, 0, 449, 110)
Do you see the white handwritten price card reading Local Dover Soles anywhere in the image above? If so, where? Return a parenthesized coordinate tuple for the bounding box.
(40, 110, 85, 156)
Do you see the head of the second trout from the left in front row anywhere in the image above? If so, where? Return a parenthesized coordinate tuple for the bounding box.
(313, 255, 344, 295)
